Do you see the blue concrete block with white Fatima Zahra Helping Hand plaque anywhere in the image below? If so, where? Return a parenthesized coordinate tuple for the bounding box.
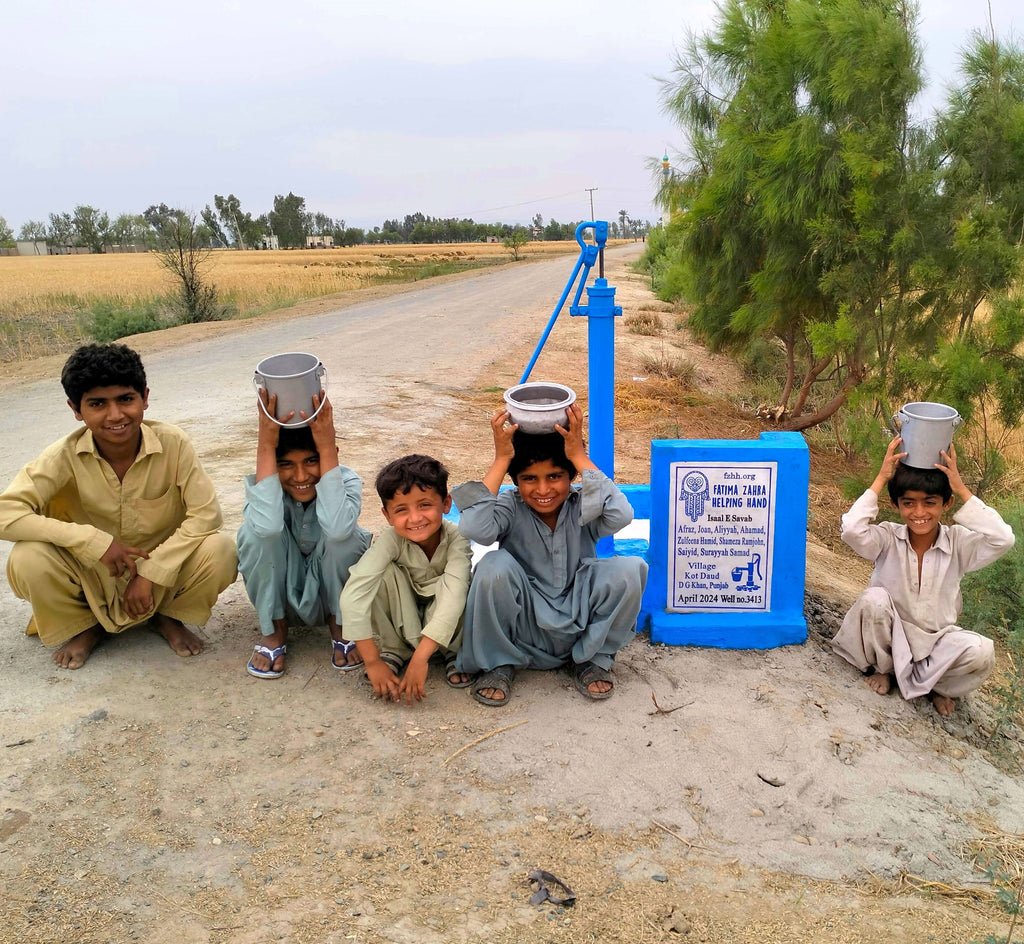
(640, 433, 810, 649)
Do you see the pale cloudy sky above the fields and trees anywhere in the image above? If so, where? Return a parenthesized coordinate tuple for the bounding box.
(0, 0, 1020, 231)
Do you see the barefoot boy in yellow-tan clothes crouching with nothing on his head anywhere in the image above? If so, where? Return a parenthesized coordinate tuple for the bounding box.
(0, 344, 237, 669)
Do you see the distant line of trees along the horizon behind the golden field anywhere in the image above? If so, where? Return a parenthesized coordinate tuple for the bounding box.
(0, 191, 650, 253)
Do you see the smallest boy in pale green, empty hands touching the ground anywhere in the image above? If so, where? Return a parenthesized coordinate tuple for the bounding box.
(341, 456, 471, 703)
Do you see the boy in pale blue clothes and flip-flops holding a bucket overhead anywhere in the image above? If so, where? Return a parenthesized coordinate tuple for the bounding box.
(238, 390, 370, 679)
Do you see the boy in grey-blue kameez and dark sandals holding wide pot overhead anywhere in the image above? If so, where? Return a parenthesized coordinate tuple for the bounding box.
(453, 404, 647, 705)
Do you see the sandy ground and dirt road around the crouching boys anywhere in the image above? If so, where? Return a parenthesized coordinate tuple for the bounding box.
(0, 250, 1024, 944)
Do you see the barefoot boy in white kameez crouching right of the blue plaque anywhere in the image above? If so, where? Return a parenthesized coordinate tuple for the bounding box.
(833, 436, 1014, 715)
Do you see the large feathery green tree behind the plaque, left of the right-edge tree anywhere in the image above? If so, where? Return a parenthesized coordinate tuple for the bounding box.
(663, 0, 931, 430)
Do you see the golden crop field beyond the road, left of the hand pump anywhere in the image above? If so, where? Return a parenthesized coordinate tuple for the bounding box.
(0, 243, 577, 361)
